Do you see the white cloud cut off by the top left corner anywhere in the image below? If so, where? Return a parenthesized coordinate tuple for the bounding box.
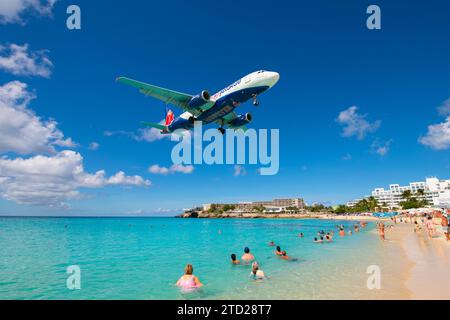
(0, 0, 56, 24)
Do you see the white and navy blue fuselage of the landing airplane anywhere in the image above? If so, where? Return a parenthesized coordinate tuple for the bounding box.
(168, 70, 280, 132)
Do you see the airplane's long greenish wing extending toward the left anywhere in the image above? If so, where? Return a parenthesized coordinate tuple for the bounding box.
(116, 77, 192, 111)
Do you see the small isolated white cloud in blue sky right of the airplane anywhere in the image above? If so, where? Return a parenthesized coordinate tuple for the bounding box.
(336, 106, 381, 140)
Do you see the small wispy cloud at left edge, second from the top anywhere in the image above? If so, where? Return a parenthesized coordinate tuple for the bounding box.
(0, 44, 53, 78)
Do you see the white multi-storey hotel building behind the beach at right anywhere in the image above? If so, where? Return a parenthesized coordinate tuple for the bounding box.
(348, 177, 450, 208)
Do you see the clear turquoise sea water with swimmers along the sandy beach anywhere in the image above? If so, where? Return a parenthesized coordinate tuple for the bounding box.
(0, 218, 404, 299)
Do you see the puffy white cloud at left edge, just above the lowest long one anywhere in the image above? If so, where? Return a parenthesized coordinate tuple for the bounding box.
(0, 81, 76, 154)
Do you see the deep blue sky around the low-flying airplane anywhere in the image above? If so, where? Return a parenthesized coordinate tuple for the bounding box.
(0, 0, 450, 215)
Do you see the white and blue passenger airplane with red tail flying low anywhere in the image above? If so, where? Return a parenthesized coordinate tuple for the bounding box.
(116, 70, 280, 134)
